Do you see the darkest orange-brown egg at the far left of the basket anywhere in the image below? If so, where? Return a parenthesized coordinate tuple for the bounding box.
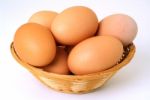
(13, 23, 56, 67)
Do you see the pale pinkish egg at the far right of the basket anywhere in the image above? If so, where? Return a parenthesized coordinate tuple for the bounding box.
(98, 14, 138, 46)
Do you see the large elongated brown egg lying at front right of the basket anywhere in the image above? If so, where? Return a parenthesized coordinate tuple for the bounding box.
(68, 36, 123, 75)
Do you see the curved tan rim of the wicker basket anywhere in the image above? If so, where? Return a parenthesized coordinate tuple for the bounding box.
(10, 42, 136, 80)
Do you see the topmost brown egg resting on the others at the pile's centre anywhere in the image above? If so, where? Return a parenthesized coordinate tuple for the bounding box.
(51, 6, 98, 45)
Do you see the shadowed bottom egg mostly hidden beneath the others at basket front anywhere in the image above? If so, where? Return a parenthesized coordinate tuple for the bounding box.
(44, 47, 70, 74)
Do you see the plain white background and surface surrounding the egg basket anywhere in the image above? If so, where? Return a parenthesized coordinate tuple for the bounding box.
(0, 0, 150, 100)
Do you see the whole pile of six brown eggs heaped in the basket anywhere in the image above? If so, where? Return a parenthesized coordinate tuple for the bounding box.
(13, 6, 137, 75)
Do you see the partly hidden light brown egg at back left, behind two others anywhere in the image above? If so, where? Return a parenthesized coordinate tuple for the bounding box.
(28, 11, 58, 29)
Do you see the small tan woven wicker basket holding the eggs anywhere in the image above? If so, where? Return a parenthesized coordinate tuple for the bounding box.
(10, 43, 135, 93)
